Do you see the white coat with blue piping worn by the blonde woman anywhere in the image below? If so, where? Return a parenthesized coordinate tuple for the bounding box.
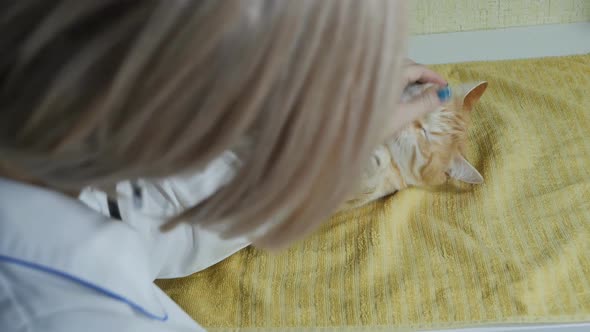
(0, 154, 249, 332)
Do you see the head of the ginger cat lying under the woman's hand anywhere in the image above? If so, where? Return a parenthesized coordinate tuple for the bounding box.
(386, 82, 487, 187)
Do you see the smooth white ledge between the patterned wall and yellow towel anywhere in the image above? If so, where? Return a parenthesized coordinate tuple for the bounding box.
(408, 22, 590, 64)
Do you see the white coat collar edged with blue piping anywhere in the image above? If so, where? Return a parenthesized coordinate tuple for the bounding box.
(0, 178, 167, 320)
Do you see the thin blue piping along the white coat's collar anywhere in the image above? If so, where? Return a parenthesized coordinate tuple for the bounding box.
(0, 255, 168, 322)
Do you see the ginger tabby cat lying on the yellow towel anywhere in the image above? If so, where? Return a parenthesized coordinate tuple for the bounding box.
(343, 82, 488, 209)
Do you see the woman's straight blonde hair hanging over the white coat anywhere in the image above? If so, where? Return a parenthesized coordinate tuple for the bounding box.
(0, 0, 405, 247)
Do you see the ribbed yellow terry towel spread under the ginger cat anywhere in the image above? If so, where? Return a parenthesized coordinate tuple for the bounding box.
(158, 55, 590, 331)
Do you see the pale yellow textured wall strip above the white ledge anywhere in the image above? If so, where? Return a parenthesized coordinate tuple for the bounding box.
(412, 0, 590, 34)
